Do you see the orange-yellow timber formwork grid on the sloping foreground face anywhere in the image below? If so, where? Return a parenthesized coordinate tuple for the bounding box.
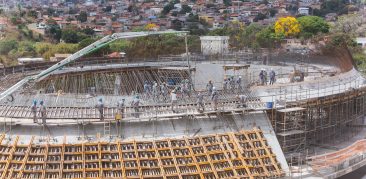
(0, 128, 284, 179)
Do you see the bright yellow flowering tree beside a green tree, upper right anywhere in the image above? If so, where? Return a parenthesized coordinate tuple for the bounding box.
(274, 17, 300, 37)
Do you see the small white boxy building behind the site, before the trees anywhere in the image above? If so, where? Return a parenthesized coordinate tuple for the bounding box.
(200, 36, 229, 55)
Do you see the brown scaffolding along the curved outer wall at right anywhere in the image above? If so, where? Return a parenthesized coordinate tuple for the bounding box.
(267, 88, 366, 159)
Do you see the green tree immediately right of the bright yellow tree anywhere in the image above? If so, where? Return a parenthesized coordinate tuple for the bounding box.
(297, 16, 329, 38)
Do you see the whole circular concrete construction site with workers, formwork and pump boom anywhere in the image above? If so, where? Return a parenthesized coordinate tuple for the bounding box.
(0, 31, 366, 179)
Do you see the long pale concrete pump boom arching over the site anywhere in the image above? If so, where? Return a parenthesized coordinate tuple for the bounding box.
(0, 31, 188, 101)
